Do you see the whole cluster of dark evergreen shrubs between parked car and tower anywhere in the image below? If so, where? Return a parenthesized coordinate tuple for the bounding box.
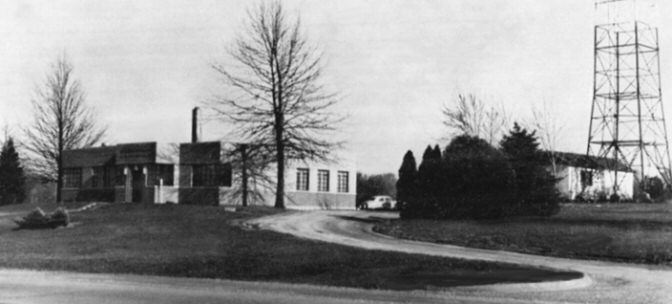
(397, 125, 559, 219)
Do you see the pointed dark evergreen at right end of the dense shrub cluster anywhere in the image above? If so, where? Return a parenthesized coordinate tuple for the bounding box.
(500, 123, 560, 216)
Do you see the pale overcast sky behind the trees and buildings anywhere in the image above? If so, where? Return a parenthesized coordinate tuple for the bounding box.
(0, 0, 672, 173)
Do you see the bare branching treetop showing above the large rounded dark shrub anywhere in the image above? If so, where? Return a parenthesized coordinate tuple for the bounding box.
(442, 94, 509, 145)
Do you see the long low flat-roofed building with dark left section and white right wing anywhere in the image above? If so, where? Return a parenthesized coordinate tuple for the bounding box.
(62, 141, 357, 209)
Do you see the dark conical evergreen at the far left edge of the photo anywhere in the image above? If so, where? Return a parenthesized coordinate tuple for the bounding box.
(0, 138, 26, 205)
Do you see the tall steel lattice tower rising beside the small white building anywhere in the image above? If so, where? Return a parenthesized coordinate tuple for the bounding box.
(587, 0, 672, 193)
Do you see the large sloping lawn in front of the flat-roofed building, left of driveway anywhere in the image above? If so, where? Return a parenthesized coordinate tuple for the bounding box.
(0, 204, 581, 290)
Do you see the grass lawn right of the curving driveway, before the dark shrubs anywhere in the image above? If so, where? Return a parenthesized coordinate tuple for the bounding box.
(375, 204, 672, 265)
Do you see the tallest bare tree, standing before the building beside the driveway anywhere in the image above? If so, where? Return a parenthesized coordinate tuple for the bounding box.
(212, 2, 342, 208)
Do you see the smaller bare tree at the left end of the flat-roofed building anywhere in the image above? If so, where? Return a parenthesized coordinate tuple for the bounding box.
(25, 56, 105, 202)
